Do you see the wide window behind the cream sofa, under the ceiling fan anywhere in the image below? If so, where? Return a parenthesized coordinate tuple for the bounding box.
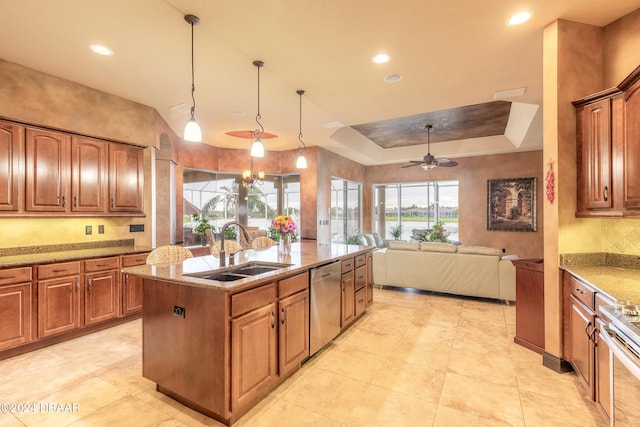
(373, 181, 460, 240)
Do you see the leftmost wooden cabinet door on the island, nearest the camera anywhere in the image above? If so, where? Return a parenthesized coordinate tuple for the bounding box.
(231, 302, 278, 412)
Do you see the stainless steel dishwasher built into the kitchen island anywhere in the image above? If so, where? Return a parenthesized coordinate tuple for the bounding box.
(309, 261, 342, 355)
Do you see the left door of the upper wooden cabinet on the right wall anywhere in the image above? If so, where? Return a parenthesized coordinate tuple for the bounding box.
(577, 99, 612, 210)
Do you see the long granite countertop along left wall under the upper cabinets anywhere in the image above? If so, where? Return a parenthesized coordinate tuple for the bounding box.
(0, 239, 153, 268)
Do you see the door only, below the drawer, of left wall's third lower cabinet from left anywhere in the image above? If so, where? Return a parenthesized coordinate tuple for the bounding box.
(84, 270, 119, 325)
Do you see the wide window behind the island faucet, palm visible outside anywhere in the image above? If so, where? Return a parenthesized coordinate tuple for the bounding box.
(183, 168, 300, 245)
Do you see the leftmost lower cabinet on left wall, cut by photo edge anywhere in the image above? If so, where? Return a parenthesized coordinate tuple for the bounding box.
(0, 267, 32, 350)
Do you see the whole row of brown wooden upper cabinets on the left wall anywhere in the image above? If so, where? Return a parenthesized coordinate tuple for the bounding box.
(0, 122, 144, 216)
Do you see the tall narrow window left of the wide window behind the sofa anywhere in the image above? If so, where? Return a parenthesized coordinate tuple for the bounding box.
(331, 178, 362, 243)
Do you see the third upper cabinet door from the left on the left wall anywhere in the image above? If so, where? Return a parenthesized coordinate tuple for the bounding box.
(71, 137, 107, 212)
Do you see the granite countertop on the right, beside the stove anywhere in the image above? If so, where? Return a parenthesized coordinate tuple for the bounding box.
(560, 253, 640, 305)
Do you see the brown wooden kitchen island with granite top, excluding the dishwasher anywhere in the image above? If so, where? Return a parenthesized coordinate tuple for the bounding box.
(123, 242, 374, 425)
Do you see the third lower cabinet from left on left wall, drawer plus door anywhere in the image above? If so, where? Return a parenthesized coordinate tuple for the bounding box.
(84, 256, 120, 325)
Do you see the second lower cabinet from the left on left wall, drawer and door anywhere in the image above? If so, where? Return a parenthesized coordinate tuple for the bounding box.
(37, 261, 80, 338)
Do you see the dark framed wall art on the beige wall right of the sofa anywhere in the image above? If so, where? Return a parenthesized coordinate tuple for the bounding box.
(487, 178, 536, 231)
